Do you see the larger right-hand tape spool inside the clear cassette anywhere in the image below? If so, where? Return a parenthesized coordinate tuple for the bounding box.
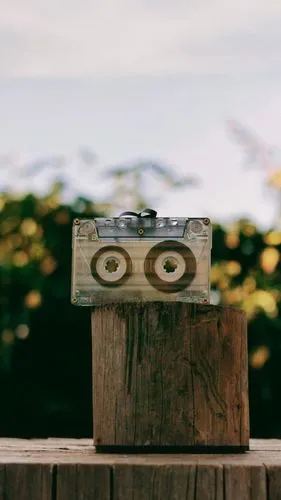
(144, 240, 197, 293)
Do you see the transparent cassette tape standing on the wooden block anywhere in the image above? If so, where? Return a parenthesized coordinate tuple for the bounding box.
(71, 216, 212, 306)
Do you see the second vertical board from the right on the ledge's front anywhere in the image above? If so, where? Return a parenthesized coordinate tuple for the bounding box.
(224, 465, 266, 500)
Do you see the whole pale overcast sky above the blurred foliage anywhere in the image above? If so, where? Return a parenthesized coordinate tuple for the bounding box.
(0, 0, 281, 227)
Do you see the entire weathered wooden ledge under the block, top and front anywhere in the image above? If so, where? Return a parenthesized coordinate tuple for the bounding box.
(0, 439, 281, 500)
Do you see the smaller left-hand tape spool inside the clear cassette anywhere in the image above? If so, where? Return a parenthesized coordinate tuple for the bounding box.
(91, 245, 132, 288)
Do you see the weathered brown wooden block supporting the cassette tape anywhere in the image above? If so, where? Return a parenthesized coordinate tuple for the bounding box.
(92, 302, 249, 453)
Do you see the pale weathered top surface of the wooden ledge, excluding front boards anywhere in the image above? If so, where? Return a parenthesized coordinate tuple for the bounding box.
(0, 438, 281, 470)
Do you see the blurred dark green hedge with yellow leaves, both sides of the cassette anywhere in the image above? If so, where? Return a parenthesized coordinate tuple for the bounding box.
(0, 189, 281, 437)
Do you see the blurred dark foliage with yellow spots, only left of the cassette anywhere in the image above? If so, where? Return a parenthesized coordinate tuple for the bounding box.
(0, 190, 100, 436)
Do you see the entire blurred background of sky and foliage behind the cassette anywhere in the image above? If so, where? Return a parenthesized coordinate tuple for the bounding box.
(0, 0, 281, 437)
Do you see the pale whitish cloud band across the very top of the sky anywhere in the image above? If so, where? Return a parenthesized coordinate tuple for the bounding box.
(0, 0, 281, 77)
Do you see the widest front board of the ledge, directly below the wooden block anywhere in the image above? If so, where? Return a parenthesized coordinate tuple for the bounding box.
(113, 465, 196, 500)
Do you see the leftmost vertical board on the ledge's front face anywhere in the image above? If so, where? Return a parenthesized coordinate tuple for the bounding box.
(5, 464, 53, 500)
